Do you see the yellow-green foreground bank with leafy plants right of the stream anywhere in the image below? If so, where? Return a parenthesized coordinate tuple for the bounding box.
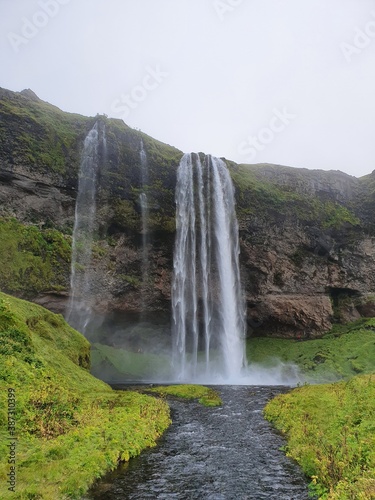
(265, 375, 375, 500)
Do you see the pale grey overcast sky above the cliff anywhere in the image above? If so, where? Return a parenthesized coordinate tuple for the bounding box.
(0, 0, 375, 177)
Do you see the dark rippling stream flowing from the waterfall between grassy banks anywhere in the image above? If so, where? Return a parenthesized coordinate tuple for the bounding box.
(85, 386, 308, 500)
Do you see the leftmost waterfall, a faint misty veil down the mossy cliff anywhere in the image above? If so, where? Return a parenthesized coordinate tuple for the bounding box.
(66, 122, 102, 333)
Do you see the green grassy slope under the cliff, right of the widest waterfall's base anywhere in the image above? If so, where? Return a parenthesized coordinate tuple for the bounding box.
(247, 319, 375, 382)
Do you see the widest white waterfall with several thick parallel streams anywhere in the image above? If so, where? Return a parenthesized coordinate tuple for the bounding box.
(172, 154, 246, 380)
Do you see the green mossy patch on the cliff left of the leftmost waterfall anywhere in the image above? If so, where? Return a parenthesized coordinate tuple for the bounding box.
(0, 218, 71, 296)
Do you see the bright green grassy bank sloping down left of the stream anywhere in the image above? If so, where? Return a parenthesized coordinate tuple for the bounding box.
(0, 293, 170, 500)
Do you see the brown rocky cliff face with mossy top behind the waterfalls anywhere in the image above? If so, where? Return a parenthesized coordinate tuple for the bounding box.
(0, 90, 375, 338)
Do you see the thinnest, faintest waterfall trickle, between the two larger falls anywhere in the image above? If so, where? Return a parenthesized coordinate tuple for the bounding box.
(139, 140, 149, 298)
